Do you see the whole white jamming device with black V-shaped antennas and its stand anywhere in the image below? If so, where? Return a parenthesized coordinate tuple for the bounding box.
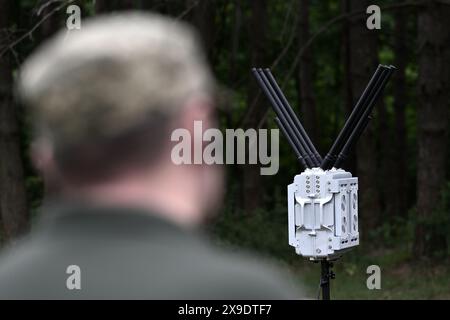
(252, 65, 395, 300)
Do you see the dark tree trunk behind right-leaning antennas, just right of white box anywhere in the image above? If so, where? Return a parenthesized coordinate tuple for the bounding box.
(350, 0, 380, 235)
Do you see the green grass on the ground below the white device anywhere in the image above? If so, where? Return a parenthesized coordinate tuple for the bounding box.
(288, 252, 450, 299)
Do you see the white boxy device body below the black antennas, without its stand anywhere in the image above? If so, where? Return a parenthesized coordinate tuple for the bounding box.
(288, 168, 359, 260)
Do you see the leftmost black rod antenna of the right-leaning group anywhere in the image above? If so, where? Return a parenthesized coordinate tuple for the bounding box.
(320, 65, 387, 170)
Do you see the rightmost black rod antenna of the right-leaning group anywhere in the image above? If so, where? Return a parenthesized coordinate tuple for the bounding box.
(334, 66, 395, 168)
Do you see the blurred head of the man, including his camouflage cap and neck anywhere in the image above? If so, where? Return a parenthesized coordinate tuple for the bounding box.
(18, 13, 221, 223)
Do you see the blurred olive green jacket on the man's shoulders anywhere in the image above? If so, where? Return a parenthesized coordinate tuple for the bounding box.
(0, 203, 301, 299)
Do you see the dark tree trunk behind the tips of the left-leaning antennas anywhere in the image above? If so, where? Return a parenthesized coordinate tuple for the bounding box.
(242, 0, 268, 213)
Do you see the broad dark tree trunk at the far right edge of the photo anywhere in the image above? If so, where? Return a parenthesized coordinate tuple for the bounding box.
(413, 2, 450, 257)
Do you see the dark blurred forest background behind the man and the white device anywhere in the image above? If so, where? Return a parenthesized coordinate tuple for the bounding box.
(0, 0, 450, 299)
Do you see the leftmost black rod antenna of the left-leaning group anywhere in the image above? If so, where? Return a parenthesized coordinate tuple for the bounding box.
(252, 68, 314, 168)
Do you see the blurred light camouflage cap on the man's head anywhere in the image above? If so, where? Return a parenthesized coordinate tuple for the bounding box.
(17, 12, 215, 148)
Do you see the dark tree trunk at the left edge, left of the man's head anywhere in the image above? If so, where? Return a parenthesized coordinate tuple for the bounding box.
(0, 0, 28, 240)
